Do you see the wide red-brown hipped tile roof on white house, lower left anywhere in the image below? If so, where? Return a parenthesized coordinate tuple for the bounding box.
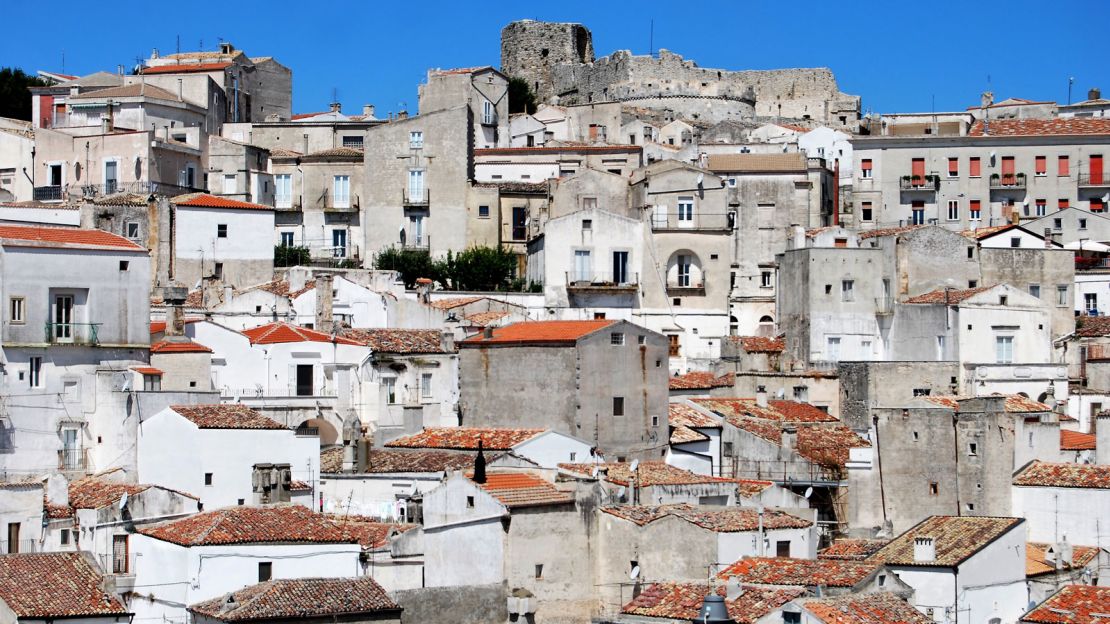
(135, 504, 357, 546)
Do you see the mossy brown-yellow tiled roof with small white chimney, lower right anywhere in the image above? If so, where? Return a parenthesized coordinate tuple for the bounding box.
(867, 512, 1021, 567)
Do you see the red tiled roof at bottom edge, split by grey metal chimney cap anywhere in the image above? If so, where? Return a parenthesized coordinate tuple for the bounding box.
(620, 583, 806, 624)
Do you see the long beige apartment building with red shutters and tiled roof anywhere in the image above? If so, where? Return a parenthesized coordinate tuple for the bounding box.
(851, 118, 1110, 230)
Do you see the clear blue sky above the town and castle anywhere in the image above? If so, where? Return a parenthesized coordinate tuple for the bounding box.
(0, 0, 1110, 117)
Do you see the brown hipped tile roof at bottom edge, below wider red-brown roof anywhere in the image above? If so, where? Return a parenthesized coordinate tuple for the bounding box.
(189, 576, 401, 622)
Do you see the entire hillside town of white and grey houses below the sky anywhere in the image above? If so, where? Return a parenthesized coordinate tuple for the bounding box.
(0, 20, 1110, 624)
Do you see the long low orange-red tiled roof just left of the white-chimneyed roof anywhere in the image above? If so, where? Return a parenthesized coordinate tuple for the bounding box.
(717, 557, 879, 587)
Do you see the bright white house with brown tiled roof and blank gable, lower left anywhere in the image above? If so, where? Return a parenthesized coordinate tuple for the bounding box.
(139, 405, 320, 509)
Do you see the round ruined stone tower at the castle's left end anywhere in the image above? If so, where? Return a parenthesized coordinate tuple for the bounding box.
(501, 20, 594, 102)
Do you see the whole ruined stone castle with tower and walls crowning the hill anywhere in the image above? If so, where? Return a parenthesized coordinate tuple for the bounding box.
(501, 20, 859, 129)
